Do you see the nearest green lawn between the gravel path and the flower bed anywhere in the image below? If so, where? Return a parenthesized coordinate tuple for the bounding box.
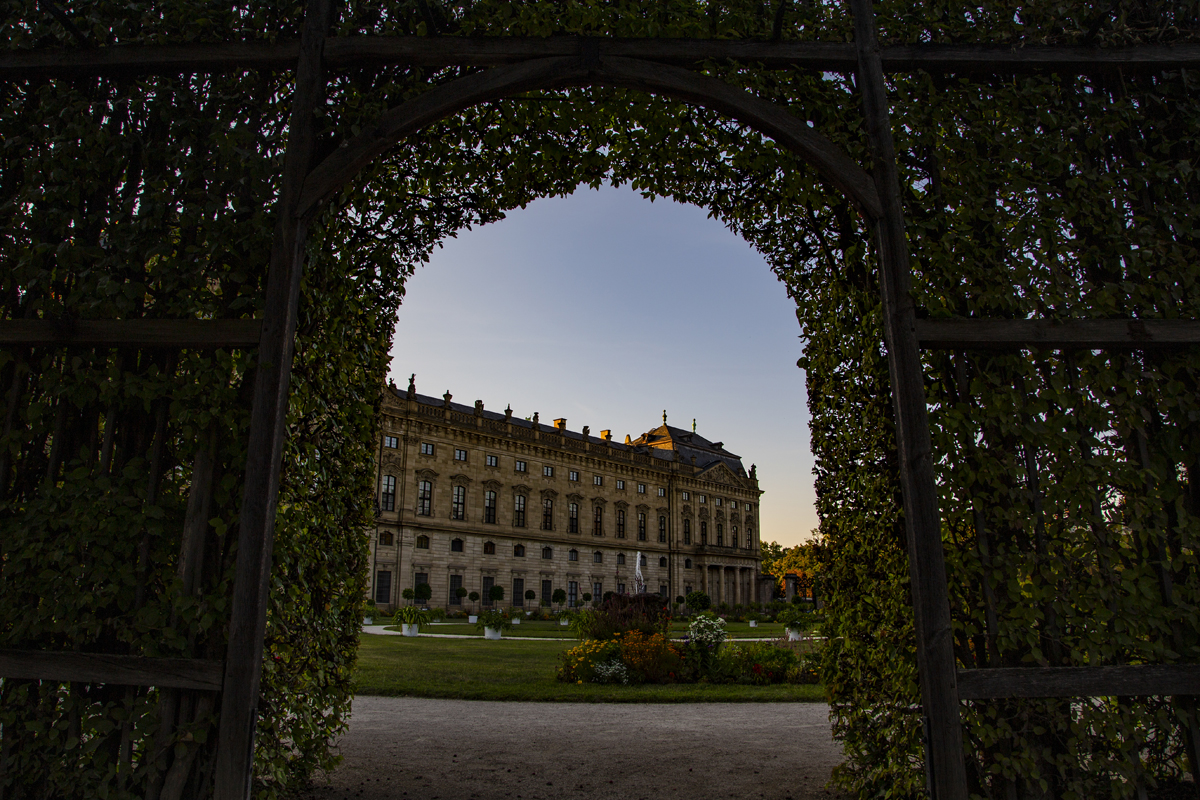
(355, 624, 824, 703)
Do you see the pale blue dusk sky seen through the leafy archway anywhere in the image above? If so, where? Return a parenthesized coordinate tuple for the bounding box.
(391, 187, 817, 546)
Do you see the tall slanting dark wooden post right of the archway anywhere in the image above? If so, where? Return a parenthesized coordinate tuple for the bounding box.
(850, 0, 967, 800)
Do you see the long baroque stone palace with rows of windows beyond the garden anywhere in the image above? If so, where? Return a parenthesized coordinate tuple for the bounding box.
(370, 381, 773, 608)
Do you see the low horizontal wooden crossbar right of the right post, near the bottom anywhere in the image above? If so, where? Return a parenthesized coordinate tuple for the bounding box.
(958, 664, 1200, 700)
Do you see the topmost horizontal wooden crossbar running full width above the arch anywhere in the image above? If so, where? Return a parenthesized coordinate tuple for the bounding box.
(0, 36, 1200, 78)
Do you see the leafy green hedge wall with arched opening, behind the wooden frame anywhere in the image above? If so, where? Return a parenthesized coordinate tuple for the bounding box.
(0, 0, 1200, 800)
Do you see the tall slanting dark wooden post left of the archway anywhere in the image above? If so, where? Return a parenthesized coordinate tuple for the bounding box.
(214, 0, 331, 800)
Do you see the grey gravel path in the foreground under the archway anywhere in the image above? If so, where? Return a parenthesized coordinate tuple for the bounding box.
(290, 697, 841, 800)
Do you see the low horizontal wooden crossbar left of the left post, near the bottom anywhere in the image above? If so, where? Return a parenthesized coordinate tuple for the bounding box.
(0, 650, 224, 692)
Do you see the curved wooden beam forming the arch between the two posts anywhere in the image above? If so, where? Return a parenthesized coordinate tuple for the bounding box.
(298, 54, 882, 219)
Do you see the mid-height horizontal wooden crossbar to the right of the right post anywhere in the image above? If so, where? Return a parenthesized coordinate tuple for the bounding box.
(917, 319, 1200, 350)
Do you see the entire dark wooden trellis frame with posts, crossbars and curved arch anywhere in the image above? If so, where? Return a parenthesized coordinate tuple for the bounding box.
(0, 0, 1200, 800)
